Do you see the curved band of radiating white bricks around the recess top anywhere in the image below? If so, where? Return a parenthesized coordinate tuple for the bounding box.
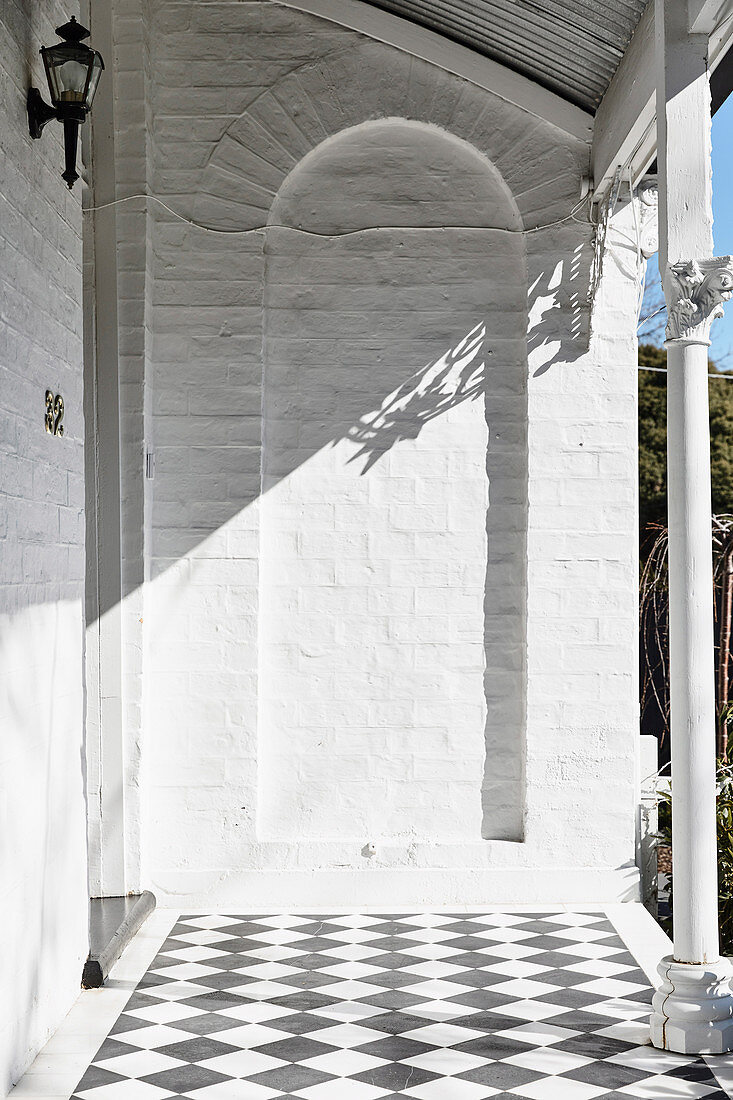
(193, 38, 588, 229)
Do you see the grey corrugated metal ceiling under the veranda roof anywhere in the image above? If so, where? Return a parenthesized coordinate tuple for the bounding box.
(358, 0, 646, 111)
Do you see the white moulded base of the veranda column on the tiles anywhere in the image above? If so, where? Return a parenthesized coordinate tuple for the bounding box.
(650, 956, 733, 1054)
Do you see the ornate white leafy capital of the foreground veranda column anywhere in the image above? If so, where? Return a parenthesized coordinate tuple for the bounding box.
(665, 256, 733, 343)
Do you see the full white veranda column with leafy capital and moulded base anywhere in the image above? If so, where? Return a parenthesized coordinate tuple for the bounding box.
(652, 0, 733, 1054)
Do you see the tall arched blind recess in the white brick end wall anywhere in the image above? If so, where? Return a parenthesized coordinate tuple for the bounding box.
(258, 118, 527, 844)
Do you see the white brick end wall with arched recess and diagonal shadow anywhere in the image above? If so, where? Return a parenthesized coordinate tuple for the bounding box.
(122, 2, 636, 905)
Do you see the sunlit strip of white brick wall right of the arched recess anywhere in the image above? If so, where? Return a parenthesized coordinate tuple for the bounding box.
(526, 218, 638, 867)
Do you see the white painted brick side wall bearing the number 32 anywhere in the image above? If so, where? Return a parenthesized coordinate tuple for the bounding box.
(0, 0, 87, 1096)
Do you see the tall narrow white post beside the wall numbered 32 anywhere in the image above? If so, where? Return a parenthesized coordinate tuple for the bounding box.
(83, 0, 129, 898)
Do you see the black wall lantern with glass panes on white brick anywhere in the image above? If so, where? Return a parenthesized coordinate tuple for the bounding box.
(28, 15, 105, 190)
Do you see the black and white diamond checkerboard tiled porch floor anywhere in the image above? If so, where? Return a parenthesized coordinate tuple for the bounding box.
(74, 913, 725, 1100)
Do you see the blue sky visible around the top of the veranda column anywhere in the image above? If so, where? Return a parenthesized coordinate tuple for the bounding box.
(639, 96, 733, 371)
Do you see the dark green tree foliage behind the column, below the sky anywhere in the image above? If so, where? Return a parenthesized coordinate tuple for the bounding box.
(638, 344, 733, 539)
